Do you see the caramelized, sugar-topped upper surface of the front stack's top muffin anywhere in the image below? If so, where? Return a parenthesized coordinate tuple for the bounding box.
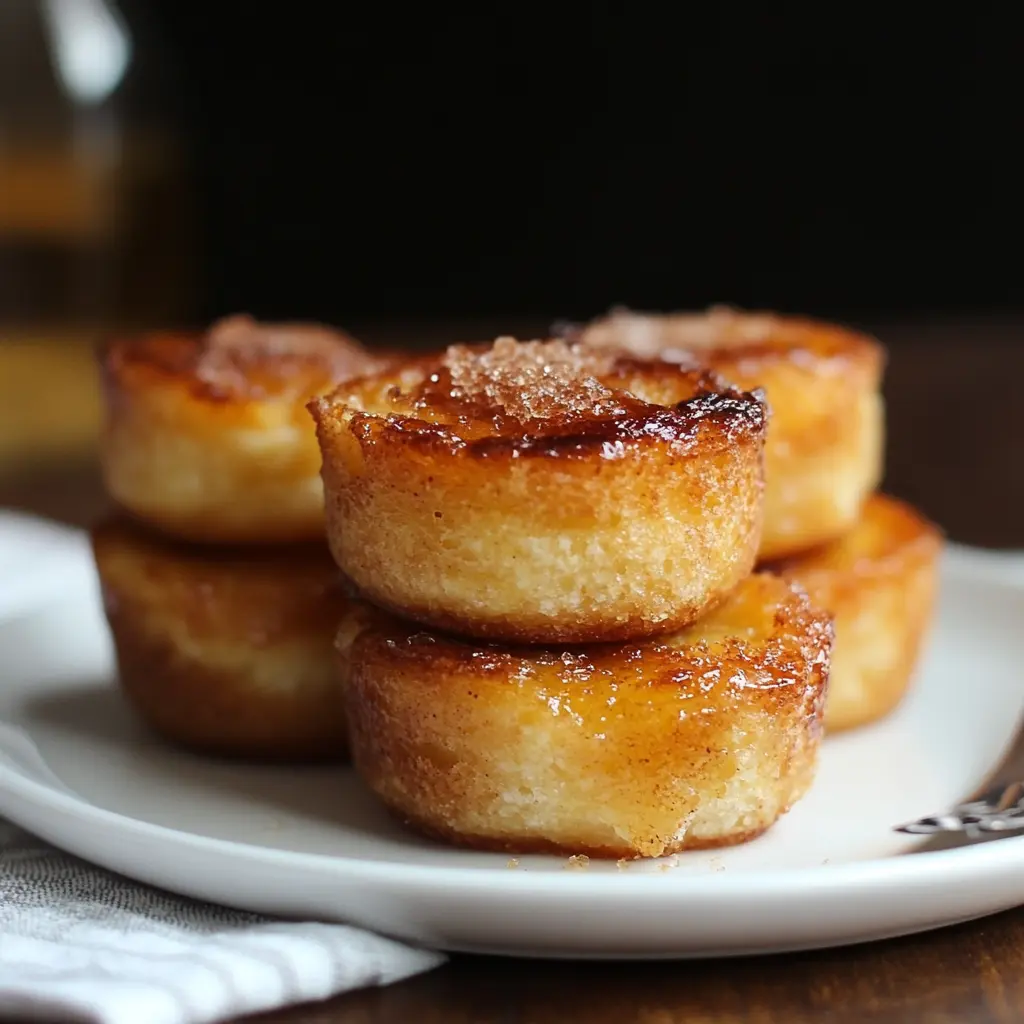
(310, 338, 764, 457)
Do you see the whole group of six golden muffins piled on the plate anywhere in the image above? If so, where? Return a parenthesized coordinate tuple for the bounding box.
(95, 310, 939, 858)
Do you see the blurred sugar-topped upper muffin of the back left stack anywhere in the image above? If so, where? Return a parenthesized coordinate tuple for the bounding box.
(100, 316, 377, 544)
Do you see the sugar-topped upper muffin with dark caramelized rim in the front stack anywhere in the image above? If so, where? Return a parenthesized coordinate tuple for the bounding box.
(310, 338, 765, 642)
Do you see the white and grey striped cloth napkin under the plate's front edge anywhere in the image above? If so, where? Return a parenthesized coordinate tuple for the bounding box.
(0, 822, 444, 1024)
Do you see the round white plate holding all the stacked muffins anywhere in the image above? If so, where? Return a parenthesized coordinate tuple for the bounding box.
(0, 549, 1024, 958)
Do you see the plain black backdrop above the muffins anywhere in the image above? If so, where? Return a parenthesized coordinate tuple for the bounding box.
(126, 0, 1024, 323)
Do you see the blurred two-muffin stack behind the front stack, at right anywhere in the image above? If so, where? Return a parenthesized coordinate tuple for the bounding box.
(571, 307, 941, 732)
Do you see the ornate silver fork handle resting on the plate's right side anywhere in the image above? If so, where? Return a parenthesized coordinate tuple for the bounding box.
(894, 726, 1024, 853)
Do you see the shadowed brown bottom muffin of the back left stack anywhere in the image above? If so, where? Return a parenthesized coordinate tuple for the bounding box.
(92, 520, 356, 761)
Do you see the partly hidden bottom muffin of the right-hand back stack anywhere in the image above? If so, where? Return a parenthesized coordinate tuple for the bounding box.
(772, 495, 942, 732)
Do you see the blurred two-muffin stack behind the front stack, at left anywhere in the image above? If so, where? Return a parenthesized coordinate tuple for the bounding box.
(92, 316, 376, 761)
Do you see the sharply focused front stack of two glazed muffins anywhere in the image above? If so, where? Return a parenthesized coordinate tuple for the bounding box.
(311, 339, 833, 858)
